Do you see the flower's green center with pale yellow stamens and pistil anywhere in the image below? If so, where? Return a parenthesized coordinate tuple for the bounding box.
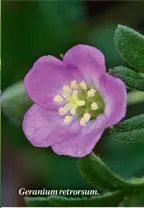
(53, 80, 105, 126)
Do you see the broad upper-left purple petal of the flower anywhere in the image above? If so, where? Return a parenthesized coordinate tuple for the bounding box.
(24, 56, 82, 109)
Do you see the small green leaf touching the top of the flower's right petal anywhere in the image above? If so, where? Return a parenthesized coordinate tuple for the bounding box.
(110, 66, 144, 91)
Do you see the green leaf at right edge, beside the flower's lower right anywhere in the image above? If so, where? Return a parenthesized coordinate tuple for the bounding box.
(105, 114, 144, 143)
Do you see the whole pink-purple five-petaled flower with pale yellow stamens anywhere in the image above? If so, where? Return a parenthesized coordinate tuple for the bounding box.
(23, 45, 126, 157)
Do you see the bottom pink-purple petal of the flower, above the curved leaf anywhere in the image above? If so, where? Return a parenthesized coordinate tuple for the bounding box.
(52, 115, 106, 157)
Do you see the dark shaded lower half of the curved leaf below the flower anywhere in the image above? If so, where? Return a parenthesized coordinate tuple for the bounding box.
(77, 156, 116, 190)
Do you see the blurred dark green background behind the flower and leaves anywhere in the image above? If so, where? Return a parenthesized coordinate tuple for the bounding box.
(1, 0, 144, 206)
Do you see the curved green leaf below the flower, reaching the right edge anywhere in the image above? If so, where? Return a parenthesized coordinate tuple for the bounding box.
(78, 153, 144, 189)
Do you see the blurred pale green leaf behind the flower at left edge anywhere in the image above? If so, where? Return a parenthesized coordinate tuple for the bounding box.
(1, 82, 32, 125)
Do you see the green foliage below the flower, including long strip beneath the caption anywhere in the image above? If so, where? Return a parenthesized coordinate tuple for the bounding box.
(25, 154, 144, 207)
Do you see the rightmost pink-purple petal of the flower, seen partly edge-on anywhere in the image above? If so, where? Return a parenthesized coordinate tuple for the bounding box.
(98, 74, 127, 127)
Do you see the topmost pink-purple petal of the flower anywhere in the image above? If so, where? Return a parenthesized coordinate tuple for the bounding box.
(63, 44, 106, 81)
